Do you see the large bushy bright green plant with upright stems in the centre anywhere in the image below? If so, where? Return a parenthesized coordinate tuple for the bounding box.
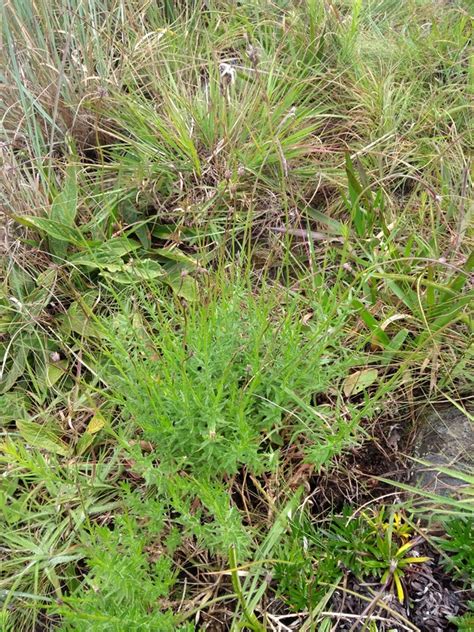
(96, 278, 362, 478)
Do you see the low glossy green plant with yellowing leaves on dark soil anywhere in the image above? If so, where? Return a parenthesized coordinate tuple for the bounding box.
(278, 505, 430, 608)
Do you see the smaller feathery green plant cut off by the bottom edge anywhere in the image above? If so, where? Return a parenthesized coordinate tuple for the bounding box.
(52, 486, 183, 631)
